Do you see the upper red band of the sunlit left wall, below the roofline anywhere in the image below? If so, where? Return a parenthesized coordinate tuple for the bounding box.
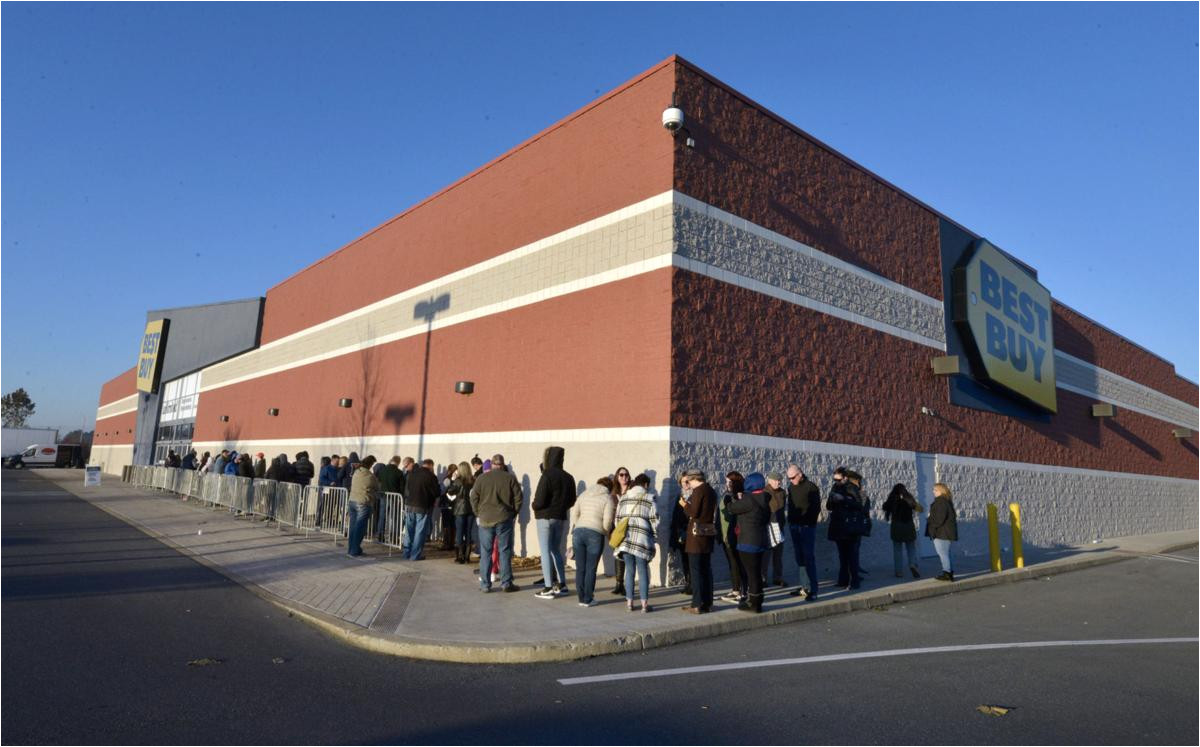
(263, 60, 674, 343)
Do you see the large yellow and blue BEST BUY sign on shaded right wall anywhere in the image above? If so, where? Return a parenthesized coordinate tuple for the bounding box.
(953, 239, 1058, 412)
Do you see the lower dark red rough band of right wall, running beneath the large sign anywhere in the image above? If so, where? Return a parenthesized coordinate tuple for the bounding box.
(671, 270, 1198, 479)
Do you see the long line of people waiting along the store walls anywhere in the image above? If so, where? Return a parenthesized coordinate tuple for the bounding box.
(169, 447, 958, 602)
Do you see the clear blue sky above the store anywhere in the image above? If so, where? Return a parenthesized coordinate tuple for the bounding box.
(0, 2, 1200, 428)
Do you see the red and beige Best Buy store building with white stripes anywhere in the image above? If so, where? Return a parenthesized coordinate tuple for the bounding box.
(94, 58, 1198, 574)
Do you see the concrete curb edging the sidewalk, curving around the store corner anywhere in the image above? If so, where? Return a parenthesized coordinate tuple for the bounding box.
(48, 480, 1198, 664)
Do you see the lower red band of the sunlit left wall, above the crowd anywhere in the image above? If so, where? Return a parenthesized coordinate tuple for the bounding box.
(196, 268, 671, 441)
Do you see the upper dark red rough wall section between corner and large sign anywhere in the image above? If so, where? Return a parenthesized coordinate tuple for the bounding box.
(674, 64, 942, 298)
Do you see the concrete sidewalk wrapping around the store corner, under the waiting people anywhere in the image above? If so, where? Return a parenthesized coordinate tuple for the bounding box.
(37, 470, 1196, 663)
